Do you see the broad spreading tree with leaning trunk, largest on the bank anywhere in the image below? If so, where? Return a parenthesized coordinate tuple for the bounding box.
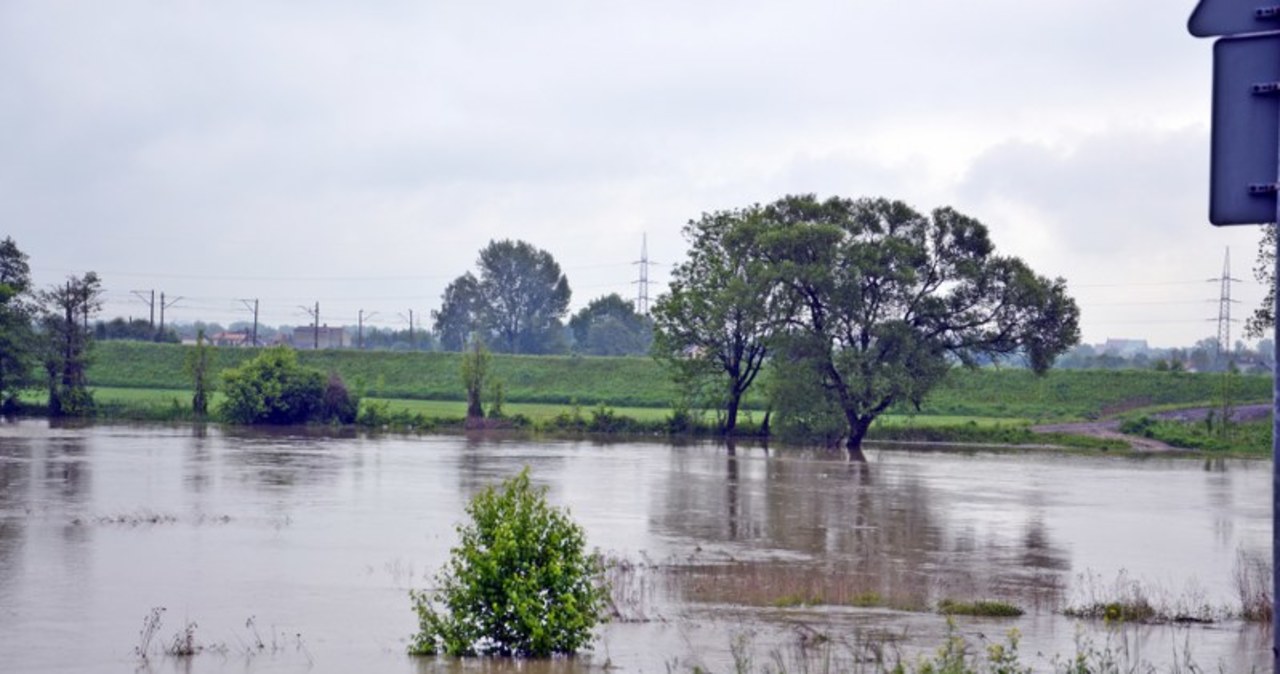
(755, 194, 1079, 451)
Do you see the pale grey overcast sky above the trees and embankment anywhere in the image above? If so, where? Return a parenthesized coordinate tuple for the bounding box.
(0, 0, 1262, 345)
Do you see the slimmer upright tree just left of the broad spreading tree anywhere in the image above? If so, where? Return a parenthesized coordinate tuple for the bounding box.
(653, 206, 788, 434)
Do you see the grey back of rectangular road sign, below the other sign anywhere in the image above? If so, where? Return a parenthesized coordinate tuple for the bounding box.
(1197, 32, 1280, 225)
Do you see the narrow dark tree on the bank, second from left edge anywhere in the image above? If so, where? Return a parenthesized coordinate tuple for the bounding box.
(38, 271, 102, 417)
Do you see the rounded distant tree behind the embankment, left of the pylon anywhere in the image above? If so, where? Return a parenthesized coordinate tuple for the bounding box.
(434, 239, 571, 353)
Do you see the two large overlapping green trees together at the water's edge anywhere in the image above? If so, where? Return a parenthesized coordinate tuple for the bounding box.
(654, 194, 1079, 451)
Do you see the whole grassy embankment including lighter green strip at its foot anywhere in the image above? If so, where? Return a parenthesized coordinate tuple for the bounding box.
(80, 341, 1271, 444)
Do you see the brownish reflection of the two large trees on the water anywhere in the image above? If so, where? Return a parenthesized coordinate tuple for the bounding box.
(655, 444, 1070, 605)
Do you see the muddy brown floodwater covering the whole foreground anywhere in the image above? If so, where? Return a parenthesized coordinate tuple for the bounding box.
(0, 421, 1271, 673)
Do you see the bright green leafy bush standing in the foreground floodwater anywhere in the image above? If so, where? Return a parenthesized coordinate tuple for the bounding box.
(410, 468, 608, 657)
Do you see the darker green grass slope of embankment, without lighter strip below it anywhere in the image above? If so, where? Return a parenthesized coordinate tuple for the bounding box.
(90, 341, 1271, 423)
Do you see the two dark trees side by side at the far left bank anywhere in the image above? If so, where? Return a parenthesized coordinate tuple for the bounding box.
(0, 237, 102, 417)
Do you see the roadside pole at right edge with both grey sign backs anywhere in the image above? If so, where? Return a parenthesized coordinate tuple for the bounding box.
(1187, 0, 1280, 674)
